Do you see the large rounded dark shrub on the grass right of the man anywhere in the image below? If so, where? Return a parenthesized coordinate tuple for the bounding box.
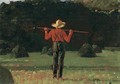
(79, 43, 96, 57)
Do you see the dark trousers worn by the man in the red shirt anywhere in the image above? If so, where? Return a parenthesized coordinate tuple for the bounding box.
(53, 42, 65, 77)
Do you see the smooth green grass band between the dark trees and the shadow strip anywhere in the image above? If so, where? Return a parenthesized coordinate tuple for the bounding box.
(0, 50, 120, 69)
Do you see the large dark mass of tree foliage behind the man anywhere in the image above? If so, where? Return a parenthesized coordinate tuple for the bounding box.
(0, 0, 120, 51)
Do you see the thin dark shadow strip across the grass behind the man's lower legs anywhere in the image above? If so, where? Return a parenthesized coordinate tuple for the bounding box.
(1, 65, 120, 71)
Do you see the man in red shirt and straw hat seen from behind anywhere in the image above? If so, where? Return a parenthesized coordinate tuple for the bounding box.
(44, 19, 73, 79)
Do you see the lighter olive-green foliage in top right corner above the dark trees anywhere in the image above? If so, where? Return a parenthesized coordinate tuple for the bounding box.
(72, 0, 119, 10)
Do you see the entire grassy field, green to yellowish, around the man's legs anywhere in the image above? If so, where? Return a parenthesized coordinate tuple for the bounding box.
(0, 50, 120, 84)
